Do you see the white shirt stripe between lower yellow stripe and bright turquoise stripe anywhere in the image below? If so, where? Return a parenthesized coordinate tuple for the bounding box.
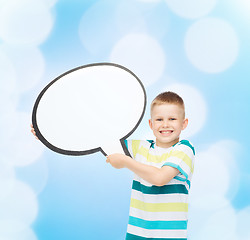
(129, 207, 188, 221)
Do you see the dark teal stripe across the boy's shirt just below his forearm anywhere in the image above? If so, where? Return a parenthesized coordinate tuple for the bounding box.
(132, 180, 188, 194)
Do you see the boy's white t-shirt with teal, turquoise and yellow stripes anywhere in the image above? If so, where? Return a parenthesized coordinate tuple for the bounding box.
(125, 140, 195, 240)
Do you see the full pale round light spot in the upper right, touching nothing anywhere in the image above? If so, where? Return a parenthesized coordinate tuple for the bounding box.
(185, 18, 239, 73)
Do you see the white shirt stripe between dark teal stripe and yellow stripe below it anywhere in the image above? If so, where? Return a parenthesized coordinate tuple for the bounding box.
(131, 189, 188, 203)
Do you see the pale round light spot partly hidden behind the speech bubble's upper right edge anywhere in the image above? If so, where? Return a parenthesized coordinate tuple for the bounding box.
(110, 34, 165, 86)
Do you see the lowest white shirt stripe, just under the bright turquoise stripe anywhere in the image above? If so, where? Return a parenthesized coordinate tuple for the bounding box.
(127, 225, 187, 238)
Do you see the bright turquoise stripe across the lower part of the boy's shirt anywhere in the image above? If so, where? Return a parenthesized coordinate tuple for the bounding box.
(129, 216, 187, 230)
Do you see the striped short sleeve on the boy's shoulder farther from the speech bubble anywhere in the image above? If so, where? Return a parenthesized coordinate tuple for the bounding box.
(163, 140, 195, 181)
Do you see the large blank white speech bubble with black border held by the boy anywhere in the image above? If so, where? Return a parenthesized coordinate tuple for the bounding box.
(32, 63, 146, 155)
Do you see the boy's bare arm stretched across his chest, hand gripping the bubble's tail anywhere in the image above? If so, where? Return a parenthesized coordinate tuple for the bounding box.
(106, 153, 179, 186)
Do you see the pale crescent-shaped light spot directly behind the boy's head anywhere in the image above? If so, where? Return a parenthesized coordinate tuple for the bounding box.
(164, 84, 207, 138)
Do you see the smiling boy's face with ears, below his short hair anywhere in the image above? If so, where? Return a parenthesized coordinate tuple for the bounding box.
(149, 103, 188, 148)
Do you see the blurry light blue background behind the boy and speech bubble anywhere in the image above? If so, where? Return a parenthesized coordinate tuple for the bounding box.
(0, 0, 250, 240)
